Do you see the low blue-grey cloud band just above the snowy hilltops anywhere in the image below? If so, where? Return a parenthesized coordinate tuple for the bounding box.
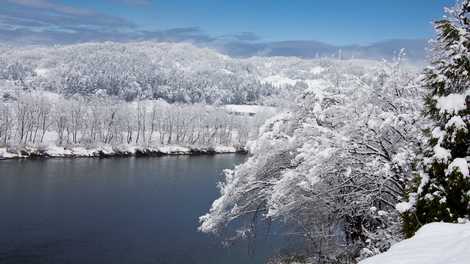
(0, 26, 427, 62)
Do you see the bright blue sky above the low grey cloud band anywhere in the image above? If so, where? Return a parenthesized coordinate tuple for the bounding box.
(0, 0, 455, 45)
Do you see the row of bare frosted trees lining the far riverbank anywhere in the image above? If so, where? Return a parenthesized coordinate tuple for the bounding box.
(0, 92, 267, 147)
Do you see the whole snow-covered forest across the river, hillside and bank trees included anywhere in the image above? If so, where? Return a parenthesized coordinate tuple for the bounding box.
(0, 42, 393, 158)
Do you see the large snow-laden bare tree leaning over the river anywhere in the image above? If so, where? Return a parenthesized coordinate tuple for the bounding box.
(200, 52, 421, 262)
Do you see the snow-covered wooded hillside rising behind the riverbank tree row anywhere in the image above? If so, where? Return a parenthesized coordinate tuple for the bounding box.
(0, 42, 400, 104)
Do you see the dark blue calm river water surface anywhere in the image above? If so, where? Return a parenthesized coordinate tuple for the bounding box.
(0, 154, 282, 264)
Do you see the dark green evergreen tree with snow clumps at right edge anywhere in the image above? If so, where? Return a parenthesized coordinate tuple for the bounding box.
(397, 0, 470, 236)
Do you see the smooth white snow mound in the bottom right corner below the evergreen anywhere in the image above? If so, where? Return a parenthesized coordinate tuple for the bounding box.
(359, 223, 470, 264)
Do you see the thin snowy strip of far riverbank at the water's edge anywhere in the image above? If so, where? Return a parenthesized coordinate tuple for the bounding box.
(0, 145, 247, 160)
